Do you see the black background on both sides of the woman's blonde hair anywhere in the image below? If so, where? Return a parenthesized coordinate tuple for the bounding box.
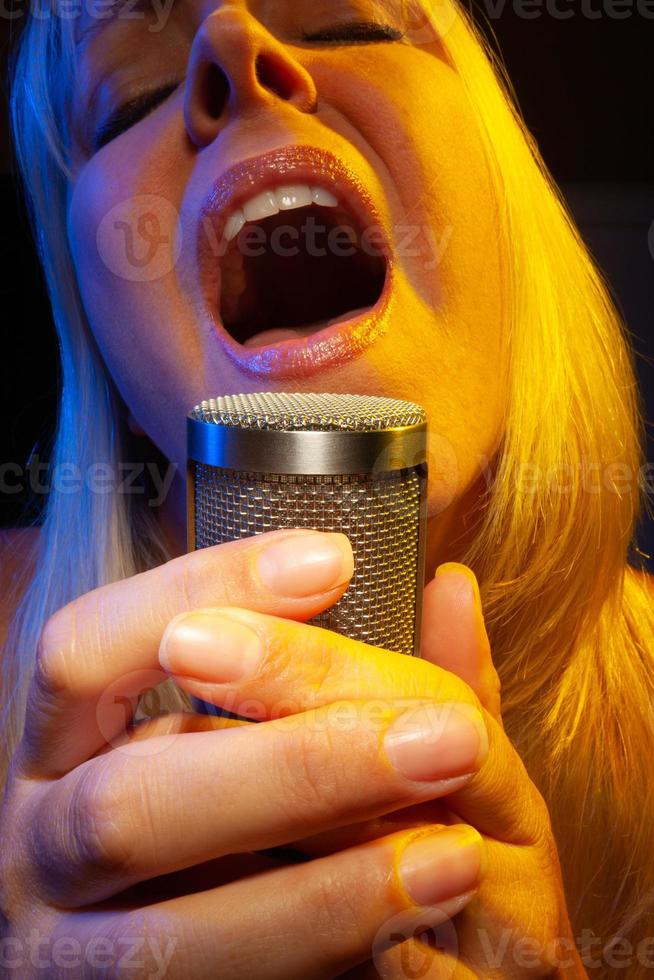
(0, 0, 654, 571)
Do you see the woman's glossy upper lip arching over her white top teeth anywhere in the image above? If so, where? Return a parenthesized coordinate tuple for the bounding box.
(197, 146, 391, 347)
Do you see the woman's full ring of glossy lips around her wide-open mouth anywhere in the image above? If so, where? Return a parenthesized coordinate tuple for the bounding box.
(197, 146, 393, 380)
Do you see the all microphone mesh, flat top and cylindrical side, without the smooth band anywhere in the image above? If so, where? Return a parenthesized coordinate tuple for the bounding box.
(189, 392, 426, 654)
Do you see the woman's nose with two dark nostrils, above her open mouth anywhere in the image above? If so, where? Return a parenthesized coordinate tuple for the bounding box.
(184, 3, 317, 147)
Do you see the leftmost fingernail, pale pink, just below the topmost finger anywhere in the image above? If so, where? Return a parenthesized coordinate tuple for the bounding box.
(159, 611, 262, 684)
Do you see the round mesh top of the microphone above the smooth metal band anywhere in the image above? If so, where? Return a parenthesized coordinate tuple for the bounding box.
(190, 392, 427, 432)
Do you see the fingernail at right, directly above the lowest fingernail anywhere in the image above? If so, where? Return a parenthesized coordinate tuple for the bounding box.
(384, 702, 488, 782)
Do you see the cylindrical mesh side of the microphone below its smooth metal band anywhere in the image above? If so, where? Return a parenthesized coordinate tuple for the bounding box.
(193, 463, 423, 654)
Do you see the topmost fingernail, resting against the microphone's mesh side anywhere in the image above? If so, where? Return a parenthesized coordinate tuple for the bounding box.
(256, 533, 354, 598)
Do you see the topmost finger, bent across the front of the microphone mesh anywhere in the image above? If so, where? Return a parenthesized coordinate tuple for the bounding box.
(17, 529, 353, 778)
